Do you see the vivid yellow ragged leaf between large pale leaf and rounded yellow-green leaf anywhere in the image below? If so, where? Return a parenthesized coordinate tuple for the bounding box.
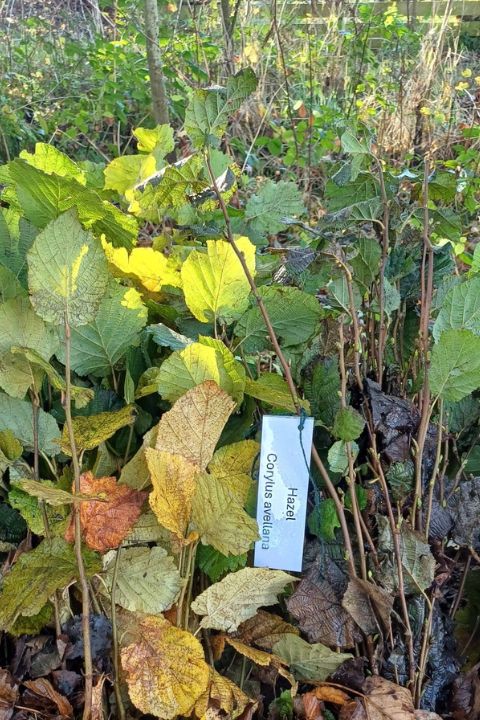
(102, 240, 181, 292)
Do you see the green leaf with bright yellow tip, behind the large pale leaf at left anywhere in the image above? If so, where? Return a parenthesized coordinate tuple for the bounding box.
(58, 283, 147, 377)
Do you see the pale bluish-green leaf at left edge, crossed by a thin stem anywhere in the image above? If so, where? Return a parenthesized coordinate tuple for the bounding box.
(0, 393, 60, 455)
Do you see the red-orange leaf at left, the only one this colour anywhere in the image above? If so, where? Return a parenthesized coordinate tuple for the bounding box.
(65, 472, 147, 552)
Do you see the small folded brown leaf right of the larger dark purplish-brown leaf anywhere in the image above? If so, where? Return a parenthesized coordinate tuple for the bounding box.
(342, 578, 393, 635)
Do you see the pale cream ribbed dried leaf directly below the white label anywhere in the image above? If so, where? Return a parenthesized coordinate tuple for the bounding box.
(191, 568, 296, 631)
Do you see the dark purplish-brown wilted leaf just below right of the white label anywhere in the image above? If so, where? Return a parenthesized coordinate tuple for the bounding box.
(287, 578, 362, 648)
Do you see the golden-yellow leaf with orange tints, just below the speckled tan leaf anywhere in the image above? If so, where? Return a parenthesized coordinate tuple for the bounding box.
(145, 448, 198, 538)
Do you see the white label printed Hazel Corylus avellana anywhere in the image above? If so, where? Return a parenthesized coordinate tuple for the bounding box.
(254, 415, 313, 571)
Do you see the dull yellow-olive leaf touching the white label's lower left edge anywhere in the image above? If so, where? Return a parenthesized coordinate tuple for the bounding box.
(192, 473, 259, 555)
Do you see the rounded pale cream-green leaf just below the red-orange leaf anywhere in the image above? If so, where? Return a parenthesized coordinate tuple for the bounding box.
(103, 547, 182, 615)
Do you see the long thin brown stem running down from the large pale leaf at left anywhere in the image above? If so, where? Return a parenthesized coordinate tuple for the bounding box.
(64, 315, 93, 720)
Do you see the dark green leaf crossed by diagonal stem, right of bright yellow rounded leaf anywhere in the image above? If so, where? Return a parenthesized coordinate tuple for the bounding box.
(235, 286, 321, 352)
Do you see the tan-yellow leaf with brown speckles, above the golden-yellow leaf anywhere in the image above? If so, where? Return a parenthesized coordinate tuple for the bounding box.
(156, 380, 235, 470)
